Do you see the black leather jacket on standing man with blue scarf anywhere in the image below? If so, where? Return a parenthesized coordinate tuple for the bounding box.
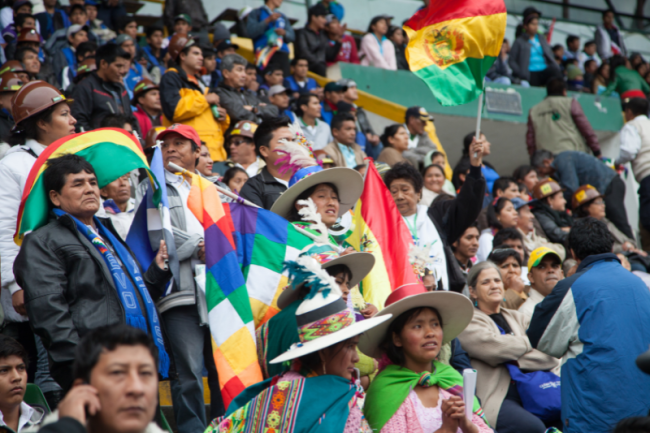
(14, 215, 171, 389)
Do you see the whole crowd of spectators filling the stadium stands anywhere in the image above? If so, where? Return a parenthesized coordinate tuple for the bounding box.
(0, 0, 650, 433)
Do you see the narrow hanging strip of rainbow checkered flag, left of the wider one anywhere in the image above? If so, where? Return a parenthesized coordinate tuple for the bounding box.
(187, 173, 263, 407)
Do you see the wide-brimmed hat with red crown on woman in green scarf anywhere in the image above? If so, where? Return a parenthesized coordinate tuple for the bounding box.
(359, 284, 474, 358)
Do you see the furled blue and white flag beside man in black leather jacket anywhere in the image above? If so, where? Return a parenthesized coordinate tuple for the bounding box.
(126, 146, 180, 295)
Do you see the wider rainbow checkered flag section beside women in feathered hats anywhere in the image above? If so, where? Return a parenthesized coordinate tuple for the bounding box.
(224, 203, 314, 328)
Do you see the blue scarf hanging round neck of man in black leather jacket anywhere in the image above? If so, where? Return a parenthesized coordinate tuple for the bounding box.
(54, 209, 169, 378)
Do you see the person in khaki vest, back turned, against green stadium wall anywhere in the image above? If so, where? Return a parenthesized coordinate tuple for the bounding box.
(526, 78, 600, 157)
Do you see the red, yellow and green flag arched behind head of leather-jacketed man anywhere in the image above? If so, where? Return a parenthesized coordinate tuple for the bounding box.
(15, 128, 161, 245)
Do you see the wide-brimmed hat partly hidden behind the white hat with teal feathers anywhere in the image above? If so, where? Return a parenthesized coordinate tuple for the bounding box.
(277, 244, 375, 310)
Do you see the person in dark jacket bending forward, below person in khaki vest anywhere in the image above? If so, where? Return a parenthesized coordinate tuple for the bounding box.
(531, 150, 634, 238)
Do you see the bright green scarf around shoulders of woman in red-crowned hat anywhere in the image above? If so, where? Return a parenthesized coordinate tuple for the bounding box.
(363, 361, 487, 432)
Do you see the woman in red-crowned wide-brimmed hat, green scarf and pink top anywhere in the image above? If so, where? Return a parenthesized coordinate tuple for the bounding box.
(359, 284, 492, 433)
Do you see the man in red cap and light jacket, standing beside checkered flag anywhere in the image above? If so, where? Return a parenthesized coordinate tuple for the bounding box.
(136, 123, 224, 433)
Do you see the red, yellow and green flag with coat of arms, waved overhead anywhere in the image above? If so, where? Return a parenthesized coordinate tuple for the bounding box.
(404, 0, 506, 105)
